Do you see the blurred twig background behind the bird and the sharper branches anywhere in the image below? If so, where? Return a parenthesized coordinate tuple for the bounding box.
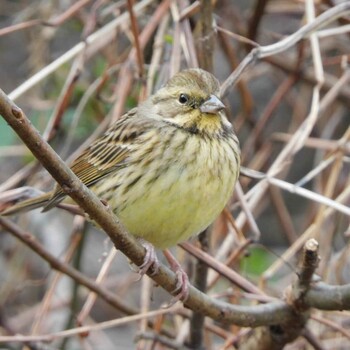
(0, 0, 350, 350)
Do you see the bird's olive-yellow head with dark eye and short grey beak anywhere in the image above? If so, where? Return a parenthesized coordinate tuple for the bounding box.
(146, 68, 228, 134)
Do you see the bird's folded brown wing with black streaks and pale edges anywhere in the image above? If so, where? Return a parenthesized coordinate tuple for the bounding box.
(44, 108, 148, 211)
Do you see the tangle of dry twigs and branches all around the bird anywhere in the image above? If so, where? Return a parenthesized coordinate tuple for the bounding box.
(0, 0, 350, 350)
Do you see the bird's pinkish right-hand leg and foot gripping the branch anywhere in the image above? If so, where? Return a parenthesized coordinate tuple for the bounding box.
(163, 249, 190, 306)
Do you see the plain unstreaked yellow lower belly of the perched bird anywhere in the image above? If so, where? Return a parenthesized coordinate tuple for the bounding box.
(118, 176, 227, 248)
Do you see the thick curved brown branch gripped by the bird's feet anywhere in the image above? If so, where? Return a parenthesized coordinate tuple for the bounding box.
(0, 86, 292, 327)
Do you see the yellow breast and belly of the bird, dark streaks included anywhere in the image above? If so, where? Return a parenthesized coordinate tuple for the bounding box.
(98, 129, 238, 248)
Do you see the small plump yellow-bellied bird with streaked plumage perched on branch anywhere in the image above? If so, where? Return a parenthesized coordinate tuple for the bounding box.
(0, 68, 240, 300)
